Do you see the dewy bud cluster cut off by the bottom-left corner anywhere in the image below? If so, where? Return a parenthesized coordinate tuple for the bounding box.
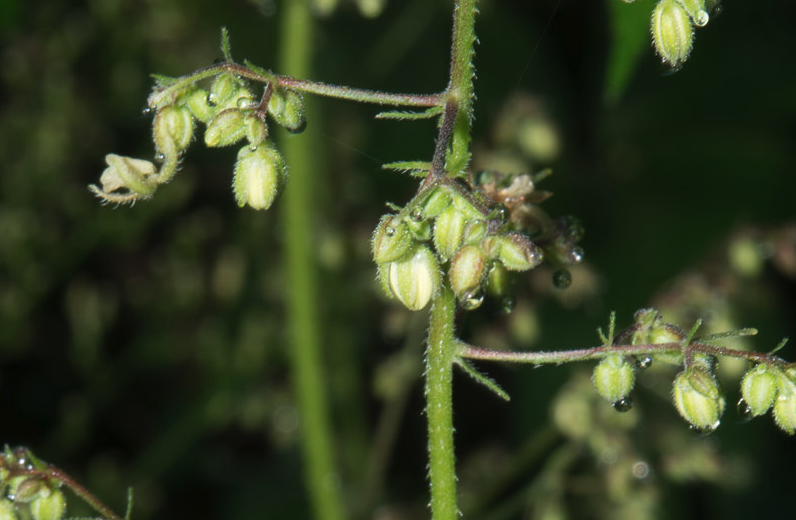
(0, 447, 66, 520)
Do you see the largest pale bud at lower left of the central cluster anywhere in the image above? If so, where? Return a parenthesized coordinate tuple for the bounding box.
(387, 246, 440, 311)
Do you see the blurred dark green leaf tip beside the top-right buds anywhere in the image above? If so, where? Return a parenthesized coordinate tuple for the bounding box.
(604, 0, 652, 104)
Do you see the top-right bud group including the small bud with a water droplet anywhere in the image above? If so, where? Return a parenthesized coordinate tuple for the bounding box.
(651, 0, 715, 68)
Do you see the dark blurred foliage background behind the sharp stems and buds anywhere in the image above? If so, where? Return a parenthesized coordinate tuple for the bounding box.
(0, 0, 796, 520)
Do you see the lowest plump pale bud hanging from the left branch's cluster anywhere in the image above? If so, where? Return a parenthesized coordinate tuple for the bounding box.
(233, 146, 287, 209)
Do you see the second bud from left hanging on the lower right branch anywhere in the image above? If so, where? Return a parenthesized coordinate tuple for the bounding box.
(674, 366, 725, 433)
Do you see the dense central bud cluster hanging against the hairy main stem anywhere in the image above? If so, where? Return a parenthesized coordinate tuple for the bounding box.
(372, 169, 582, 311)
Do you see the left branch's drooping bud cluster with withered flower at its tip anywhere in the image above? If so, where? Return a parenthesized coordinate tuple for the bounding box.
(90, 33, 306, 209)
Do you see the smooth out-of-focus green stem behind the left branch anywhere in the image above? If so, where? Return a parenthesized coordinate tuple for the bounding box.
(280, 0, 345, 520)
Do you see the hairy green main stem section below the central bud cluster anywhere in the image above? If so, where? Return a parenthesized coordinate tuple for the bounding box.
(426, 284, 459, 520)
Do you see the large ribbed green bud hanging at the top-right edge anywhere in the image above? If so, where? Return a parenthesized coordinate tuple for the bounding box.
(652, 0, 694, 68)
